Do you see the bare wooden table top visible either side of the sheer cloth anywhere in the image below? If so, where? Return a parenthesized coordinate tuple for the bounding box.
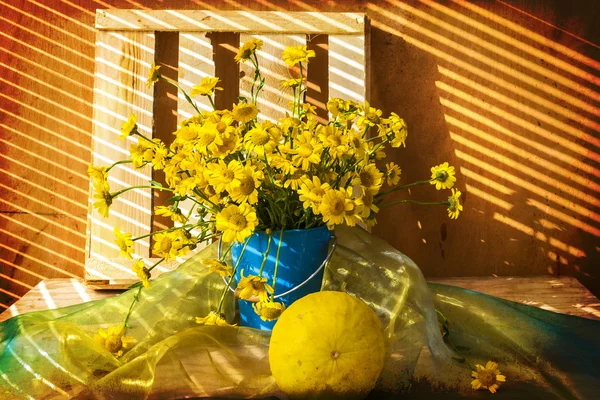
(0, 276, 600, 321)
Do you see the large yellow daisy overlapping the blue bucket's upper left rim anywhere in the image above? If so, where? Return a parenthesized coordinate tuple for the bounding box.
(216, 204, 258, 242)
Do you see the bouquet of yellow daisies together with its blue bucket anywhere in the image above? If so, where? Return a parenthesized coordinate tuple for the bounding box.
(89, 39, 462, 334)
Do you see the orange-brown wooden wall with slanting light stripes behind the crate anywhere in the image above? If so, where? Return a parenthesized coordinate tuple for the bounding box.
(0, 0, 600, 307)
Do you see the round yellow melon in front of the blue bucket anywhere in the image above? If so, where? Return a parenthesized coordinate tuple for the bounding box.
(269, 291, 385, 399)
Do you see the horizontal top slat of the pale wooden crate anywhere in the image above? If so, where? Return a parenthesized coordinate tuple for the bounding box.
(96, 10, 364, 35)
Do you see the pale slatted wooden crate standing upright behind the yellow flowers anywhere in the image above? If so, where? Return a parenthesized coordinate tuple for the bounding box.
(85, 10, 370, 289)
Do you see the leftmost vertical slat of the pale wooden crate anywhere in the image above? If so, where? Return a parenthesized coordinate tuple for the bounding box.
(88, 32, 154, 268)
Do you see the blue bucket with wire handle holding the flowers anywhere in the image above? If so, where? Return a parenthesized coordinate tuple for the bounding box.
(231, 226, 331, 330)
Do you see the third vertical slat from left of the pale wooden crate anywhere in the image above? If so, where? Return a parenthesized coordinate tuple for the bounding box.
(240, 33, 306, 122)
